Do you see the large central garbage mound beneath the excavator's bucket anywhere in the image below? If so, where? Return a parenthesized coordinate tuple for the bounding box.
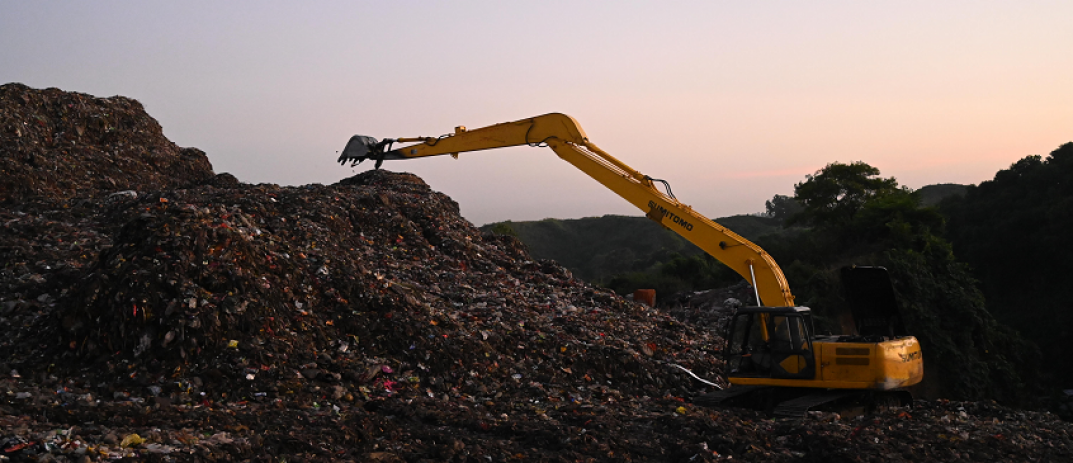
(35, 170, 720, 405)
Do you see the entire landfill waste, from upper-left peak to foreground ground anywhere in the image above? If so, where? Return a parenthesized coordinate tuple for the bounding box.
(0, 84, 1073, 462)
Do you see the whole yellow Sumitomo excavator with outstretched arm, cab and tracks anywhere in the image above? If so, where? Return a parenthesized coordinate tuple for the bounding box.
(338, 114, 924, 416)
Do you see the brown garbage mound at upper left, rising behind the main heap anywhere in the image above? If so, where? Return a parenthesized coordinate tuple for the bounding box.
(0, 84, 212, 203)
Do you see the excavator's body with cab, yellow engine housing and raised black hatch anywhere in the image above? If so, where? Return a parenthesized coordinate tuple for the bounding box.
(723, 266, 924, 400)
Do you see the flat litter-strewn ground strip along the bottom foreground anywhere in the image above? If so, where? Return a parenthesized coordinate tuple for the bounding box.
(0, 378, 1073, 462)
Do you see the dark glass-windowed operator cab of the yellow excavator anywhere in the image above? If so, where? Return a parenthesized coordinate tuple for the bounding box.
(725, 307, 815, 379)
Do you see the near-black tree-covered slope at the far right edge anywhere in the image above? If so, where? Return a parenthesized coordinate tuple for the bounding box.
(941, 143, 1073, 388)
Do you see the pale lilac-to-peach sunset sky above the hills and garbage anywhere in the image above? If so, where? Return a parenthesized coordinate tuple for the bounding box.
(0, 1, 1073, 225)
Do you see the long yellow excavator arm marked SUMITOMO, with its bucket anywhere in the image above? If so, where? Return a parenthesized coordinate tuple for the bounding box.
(339, 114, 794, 307)
